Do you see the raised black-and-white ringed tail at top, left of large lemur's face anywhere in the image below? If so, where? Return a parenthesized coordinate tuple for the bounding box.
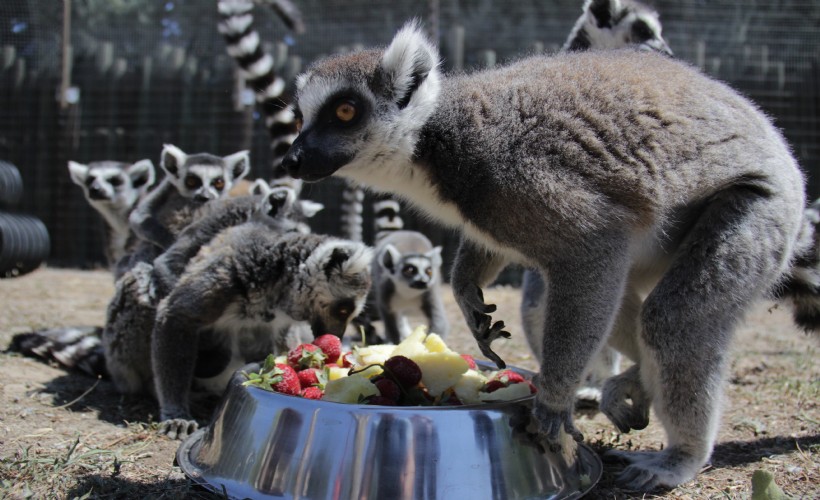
(218, 0, 304, 178)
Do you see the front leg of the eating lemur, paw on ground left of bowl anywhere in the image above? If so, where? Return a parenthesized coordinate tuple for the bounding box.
(151, 261, 234, 439)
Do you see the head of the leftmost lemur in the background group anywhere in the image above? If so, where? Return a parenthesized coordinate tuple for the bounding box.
(68, 160, 155, 211)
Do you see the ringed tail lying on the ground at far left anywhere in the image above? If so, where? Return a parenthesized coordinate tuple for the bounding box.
(7, 326, 108, 378)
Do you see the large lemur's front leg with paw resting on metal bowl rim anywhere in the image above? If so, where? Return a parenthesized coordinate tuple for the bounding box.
(533, 231, 629, 448)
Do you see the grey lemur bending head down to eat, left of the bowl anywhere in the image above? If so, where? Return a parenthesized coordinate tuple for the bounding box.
(152, 228, 372, 437)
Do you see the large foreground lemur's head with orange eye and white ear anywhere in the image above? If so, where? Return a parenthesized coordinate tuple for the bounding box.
(282, 22, 440, 181)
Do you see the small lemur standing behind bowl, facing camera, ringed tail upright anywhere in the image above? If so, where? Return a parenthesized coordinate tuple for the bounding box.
(372, 200, 450, 344)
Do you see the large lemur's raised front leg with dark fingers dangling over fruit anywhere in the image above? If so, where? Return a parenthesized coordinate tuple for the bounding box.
(451, 236, 510, 368)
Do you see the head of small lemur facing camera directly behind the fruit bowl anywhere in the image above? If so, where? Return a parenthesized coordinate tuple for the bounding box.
(378, 243, 441, 296)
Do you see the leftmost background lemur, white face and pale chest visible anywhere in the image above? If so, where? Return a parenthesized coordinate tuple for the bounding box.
(68, 160, 156, 277)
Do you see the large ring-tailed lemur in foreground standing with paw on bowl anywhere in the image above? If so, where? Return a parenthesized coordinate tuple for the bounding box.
(283, 24, 811, 490)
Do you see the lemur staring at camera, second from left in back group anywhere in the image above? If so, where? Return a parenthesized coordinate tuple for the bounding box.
(129, 144, 250, 254)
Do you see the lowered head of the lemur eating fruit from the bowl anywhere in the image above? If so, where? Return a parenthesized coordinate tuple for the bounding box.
(293, 238, 373, 338)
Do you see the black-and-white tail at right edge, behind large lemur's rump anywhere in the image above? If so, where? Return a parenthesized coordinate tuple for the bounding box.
(777, 199, 820, 336)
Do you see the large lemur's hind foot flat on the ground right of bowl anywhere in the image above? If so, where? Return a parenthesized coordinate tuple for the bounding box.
(604, 448, 702, 492)
